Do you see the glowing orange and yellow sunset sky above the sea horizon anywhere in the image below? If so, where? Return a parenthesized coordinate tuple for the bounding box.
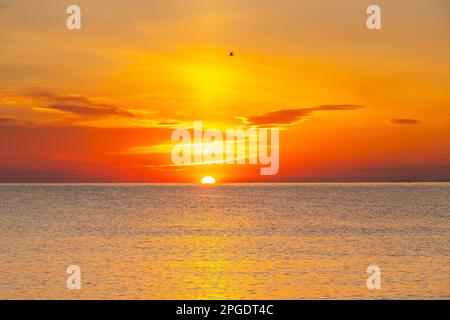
(0, 0, 450, 183)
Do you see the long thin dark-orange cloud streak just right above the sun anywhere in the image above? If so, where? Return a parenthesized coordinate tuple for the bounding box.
(245, 104, 363, 126)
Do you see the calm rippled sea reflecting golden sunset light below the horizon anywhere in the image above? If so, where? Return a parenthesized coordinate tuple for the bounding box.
(0, 184, 450, 299)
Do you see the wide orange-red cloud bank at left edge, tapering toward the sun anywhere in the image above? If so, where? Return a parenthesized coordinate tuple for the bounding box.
(0, 86, 190, 128)
